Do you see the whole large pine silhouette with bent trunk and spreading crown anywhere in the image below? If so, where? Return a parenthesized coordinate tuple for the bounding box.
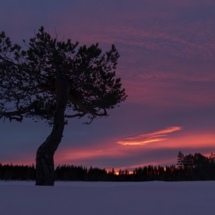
(0, 27, 127, 186)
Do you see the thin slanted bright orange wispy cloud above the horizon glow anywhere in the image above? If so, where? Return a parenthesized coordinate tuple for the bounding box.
(117, 126, 182, 146)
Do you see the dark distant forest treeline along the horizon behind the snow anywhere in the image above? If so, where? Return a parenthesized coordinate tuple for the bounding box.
(0, 152, 215, 181)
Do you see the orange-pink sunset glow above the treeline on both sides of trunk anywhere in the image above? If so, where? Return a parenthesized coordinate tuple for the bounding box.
(1, 127, 215, 172)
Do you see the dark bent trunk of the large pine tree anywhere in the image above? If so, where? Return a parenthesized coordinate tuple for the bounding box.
(36, 74, 69, 186)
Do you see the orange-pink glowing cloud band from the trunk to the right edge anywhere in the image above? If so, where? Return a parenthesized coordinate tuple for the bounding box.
(55, 127, 215, 171)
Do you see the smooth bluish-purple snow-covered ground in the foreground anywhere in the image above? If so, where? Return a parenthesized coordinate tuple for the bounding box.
(0, 181, 215, 215)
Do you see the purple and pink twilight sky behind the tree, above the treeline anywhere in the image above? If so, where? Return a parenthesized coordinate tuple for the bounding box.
(0, 0, 215, 169)
